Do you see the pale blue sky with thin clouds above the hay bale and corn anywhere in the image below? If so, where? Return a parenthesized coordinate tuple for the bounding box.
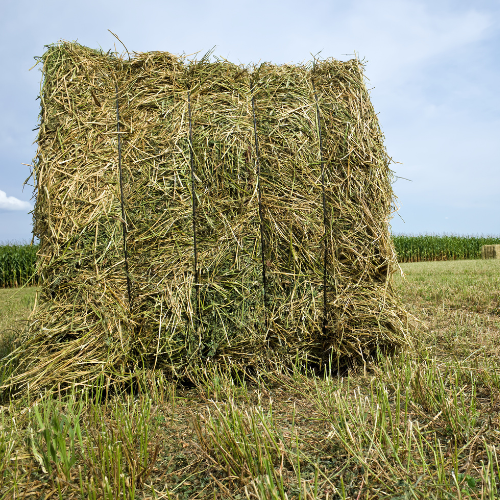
(0, 0, 500, 242)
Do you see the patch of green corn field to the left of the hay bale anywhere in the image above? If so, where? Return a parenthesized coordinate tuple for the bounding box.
(0, 243, 38, 287)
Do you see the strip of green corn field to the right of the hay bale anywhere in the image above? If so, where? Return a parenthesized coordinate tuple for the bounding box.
(392, 234, 500, 262)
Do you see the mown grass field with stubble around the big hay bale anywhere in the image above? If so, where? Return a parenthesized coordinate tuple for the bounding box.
(0, 260, 500, 500)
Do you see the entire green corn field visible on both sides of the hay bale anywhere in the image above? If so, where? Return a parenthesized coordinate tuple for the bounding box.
(0, 234, 500, 288)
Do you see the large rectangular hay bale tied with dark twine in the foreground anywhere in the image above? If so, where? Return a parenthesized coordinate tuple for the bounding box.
(1, 43, 406, 389)
